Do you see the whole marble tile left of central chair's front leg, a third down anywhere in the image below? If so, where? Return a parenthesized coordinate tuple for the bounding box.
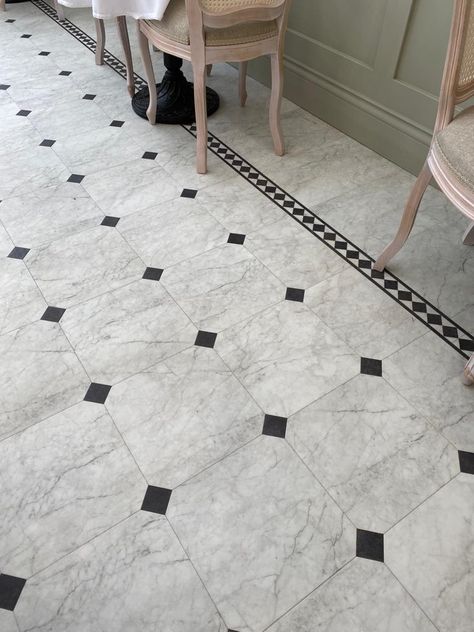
(82, 158, 184, 217)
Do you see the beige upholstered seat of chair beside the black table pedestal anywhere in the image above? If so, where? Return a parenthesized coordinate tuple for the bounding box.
(146, 0, 278, 46)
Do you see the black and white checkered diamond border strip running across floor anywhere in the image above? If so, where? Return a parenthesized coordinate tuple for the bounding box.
(31, 0, 474, 358)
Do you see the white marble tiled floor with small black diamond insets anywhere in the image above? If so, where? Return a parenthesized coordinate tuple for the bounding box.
(0, 0, 474, 632)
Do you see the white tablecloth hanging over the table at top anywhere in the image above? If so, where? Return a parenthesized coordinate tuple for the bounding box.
(58, 0, 170, 20)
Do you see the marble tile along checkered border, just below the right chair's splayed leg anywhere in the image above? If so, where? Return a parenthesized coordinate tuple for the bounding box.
(305, 267, 426, 359)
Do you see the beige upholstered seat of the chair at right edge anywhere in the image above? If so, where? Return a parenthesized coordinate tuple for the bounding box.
(433, 106, 474, 192)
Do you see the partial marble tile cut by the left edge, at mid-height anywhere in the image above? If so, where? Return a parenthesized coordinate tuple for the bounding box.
(0, 257, 46, 334)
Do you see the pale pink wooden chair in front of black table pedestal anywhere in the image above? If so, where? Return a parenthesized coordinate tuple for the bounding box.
(139, 0, 290, 173)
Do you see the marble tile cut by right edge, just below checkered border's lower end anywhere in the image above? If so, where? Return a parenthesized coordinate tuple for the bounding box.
(383, 333, 474, 452)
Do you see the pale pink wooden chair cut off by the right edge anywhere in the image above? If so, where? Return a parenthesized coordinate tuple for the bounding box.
(374, 0, 474, 384)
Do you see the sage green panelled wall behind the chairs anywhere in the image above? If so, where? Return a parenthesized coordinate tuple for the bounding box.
(251, 0, 453, 172)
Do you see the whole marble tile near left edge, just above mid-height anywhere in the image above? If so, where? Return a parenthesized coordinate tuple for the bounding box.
(26, 226, 145, 307)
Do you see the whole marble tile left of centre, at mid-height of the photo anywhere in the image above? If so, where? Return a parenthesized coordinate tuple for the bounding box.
(61, 279, 197, 384)
